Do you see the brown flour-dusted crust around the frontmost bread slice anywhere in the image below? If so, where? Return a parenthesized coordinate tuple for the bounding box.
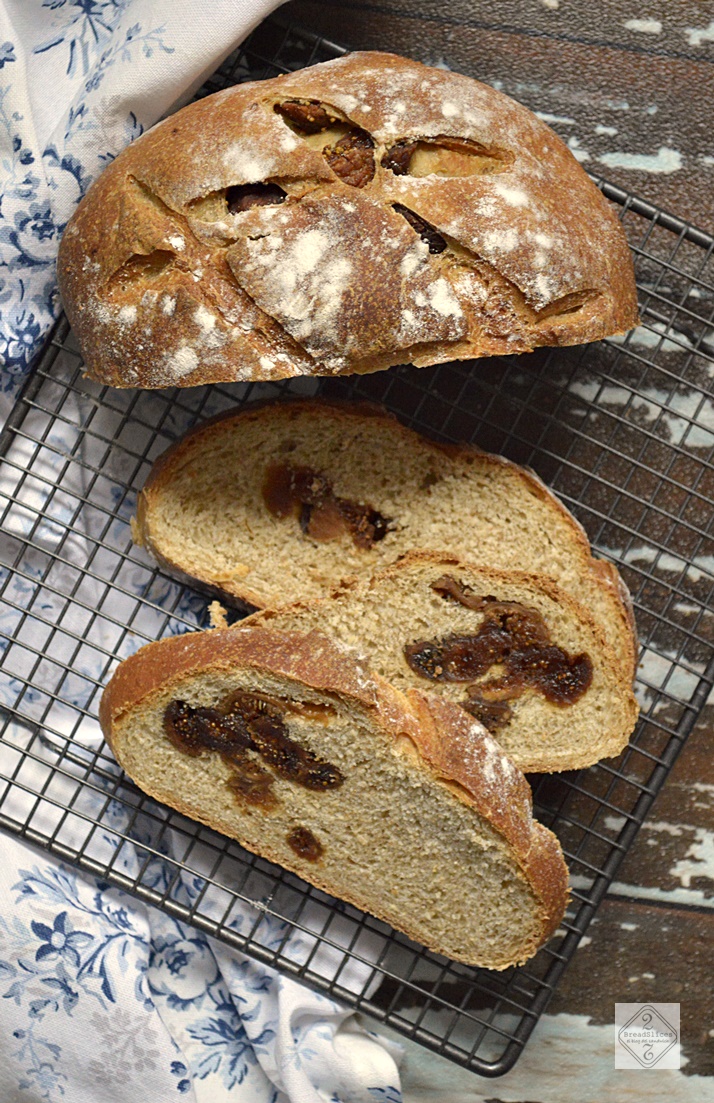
(99, 628, 568, 968)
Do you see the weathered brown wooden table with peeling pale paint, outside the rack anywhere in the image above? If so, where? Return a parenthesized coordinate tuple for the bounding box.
(283, 0, 714, 1103)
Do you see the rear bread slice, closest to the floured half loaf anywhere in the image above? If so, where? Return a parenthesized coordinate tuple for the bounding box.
(134, 400, 637, 676)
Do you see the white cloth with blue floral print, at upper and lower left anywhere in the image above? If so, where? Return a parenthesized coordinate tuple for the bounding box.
(0, 0, 402, 1103)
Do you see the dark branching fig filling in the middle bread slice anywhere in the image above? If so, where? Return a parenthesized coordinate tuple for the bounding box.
(404, 576, 593, 731)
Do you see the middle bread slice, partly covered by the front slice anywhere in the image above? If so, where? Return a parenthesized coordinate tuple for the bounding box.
(248, 552, 638, 772)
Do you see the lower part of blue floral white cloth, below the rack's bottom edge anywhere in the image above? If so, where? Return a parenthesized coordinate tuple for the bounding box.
(0, 839, 402, 1103)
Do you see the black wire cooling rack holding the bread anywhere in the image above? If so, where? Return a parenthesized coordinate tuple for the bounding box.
(0, 12, 714, 1075)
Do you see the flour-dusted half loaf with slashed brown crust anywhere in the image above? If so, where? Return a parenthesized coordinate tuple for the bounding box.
(58, 53, 638, 387)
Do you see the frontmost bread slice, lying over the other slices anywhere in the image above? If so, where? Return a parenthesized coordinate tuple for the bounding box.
(99, 628, 567, 970)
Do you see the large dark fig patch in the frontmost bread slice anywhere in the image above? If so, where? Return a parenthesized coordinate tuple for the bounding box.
(163, 690, 344, 807)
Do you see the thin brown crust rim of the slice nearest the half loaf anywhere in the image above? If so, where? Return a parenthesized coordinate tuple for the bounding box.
(134, 398, 638, 678)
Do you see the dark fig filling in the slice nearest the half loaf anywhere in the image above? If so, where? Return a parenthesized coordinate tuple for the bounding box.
(263, 463, 390, 549)
